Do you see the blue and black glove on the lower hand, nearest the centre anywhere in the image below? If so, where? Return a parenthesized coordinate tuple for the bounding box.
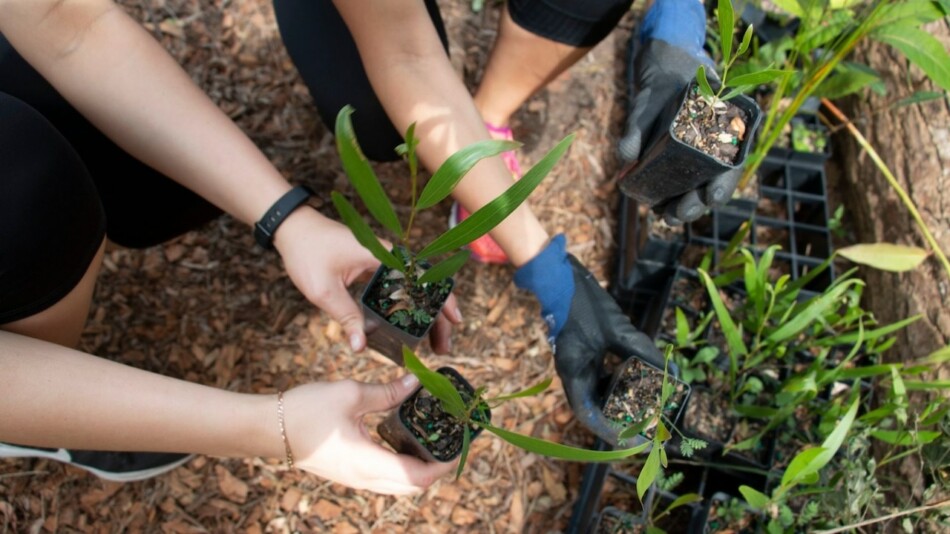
(515, 234, 675, 445)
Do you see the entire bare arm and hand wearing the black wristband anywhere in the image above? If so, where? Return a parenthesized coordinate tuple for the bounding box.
(0, 0, 458, 351)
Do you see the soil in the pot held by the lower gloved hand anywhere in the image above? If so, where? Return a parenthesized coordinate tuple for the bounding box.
(604, 358, 687, 437)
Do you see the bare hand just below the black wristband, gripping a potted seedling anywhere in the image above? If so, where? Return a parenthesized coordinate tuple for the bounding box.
(274, 207, 462, 354)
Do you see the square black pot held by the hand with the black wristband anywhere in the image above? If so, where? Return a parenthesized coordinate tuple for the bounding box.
(360, 256, 455, 366)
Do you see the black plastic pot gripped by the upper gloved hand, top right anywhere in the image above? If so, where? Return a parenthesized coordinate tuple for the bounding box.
(620, 82, 762, 206)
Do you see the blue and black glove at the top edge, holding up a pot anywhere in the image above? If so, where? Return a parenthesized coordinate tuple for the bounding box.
(618, 0, 742, 225)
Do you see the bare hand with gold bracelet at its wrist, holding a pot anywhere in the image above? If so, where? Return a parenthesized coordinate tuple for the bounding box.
(284, 374, 456, 495)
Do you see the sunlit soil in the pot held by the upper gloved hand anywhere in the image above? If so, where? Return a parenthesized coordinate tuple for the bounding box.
(673, 86, 748, 165)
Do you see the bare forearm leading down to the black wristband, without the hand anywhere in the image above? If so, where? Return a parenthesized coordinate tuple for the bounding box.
(0, 0, 290, 223)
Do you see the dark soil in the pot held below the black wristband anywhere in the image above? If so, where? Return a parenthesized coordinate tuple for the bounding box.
(365, 265, 452, 337)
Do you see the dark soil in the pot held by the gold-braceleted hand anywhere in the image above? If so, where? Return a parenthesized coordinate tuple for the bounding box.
(399, 373, 485, 462)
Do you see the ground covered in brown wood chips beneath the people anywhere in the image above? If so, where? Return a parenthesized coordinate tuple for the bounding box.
(0, 0, 633, 533)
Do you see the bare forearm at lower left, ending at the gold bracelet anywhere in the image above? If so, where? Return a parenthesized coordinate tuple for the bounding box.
(0, 331, 283, 457)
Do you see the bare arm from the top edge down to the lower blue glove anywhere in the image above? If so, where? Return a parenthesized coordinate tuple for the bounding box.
(335, 0, 548, 266)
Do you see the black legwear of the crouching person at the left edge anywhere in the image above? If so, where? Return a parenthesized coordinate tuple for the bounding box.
(0, 35, 220, 324)
